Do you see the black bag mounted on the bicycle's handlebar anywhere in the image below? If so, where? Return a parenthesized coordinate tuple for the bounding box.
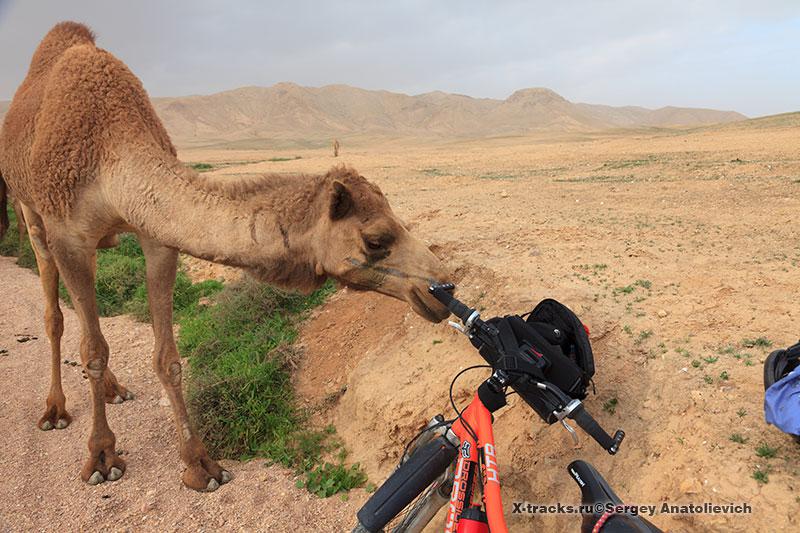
(480, 299, 594, 424)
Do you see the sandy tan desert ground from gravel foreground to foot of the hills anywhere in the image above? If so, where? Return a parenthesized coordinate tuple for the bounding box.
(0, 111, 800, 531)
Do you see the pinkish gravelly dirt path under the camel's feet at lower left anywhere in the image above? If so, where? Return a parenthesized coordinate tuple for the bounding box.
(0, 257, 363, 532)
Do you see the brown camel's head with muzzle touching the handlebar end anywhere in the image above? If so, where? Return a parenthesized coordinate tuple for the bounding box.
(315, 167, 449, 322)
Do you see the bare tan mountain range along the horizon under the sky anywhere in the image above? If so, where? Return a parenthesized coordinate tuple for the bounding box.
(0, 83, 747, 146)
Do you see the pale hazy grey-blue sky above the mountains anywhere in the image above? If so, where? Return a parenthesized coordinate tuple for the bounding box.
(0, 0, 800, 116)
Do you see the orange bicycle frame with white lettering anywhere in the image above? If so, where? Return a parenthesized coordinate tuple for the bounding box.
(444, 393, 508, 533)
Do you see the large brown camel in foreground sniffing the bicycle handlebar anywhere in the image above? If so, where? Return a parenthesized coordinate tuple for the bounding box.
(0, 22, 448, 491)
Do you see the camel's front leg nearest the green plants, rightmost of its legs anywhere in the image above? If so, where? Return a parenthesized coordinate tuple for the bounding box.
(139, 236, 231, 491)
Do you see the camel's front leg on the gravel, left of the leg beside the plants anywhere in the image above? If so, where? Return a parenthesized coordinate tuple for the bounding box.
(48, 235, 125, 485)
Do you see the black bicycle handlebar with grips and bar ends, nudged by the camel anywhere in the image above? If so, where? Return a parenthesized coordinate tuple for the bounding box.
(428, 283, 625, 455)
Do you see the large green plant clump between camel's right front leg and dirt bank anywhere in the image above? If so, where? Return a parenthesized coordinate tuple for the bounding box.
(179, 281, 366, 496)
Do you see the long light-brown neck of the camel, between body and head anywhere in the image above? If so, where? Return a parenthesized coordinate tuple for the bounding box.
(115, 152, 320, 272)
